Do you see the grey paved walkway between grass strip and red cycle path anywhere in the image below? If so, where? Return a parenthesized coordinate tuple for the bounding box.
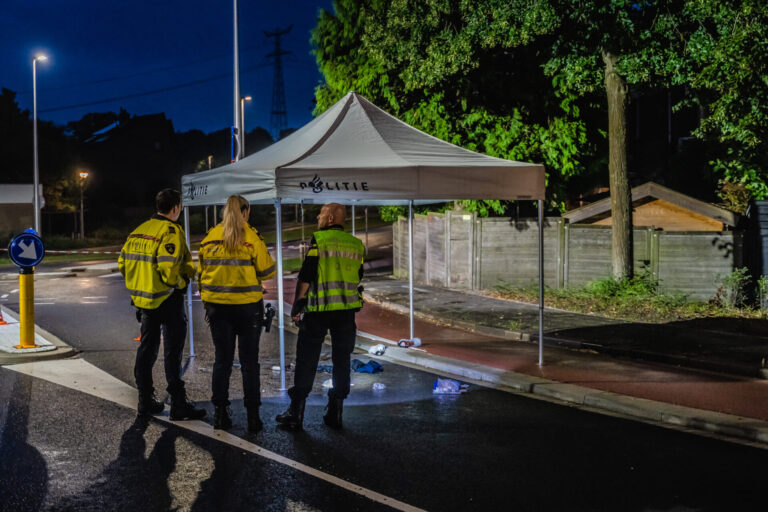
(365, 276, 768, 378)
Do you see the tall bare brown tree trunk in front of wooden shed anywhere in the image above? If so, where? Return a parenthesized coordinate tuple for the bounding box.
(603, 50, 632, 279)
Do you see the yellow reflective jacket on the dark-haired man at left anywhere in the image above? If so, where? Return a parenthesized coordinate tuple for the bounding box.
(117, 214, 195, 309)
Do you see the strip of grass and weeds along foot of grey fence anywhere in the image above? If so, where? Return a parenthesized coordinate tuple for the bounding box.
(491, 274, 766, 323)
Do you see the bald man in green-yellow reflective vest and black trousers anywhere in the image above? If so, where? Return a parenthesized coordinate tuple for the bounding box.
(276, 203, 365, 430)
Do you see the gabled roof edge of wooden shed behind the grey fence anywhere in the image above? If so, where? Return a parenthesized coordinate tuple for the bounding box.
(563, 181, 739, 227)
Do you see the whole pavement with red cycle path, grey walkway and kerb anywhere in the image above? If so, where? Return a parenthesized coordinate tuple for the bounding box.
(280, 273, 768, 443)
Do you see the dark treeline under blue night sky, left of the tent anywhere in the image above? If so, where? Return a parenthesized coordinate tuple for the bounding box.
(0, 88, 273, 235)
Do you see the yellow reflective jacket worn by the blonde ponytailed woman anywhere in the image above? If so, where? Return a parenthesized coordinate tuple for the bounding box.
(198, 223, 275, 304)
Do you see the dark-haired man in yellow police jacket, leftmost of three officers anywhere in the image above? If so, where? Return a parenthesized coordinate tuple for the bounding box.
(118, 188, 205, 420)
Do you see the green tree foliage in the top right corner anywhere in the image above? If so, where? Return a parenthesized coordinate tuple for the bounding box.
(686, 0, 768, 199)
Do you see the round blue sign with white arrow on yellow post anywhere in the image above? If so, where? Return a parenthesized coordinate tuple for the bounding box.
(8, 228, 45, 349)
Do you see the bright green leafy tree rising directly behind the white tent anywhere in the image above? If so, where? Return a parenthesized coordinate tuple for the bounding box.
(312, 0, 599, 218)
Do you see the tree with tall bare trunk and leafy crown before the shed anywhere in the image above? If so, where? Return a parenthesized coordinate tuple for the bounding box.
(516, 0, 690, 279)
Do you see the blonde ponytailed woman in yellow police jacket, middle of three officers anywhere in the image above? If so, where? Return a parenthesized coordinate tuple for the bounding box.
(198, 196, 275, 432)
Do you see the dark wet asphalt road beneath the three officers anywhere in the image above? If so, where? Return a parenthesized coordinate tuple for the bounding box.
(0, 270, 767, 511)
